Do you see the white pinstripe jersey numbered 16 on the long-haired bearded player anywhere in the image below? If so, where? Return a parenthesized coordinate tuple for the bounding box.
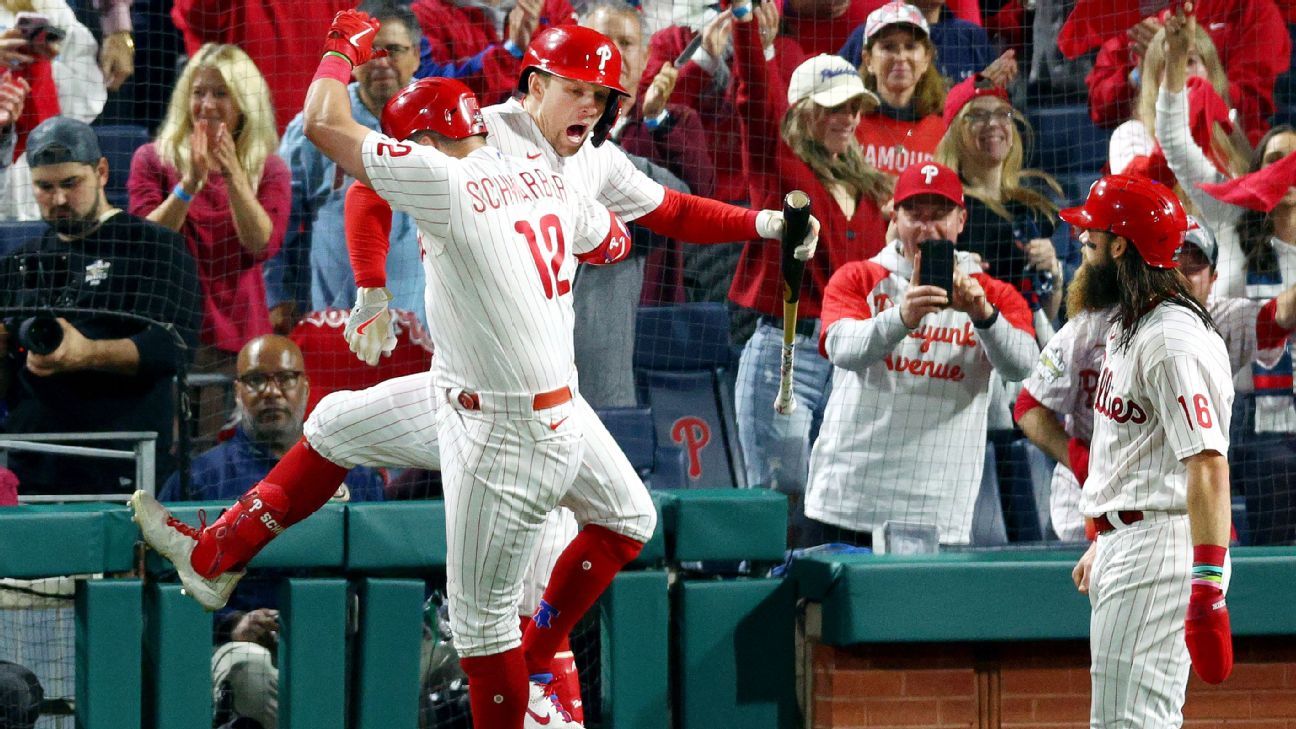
(1081, 302, 1234, 516)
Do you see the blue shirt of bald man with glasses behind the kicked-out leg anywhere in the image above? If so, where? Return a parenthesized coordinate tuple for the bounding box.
(158, 425, 384, 502)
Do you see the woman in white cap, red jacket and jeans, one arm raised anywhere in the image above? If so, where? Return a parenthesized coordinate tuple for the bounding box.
(730, 3, 892, 539)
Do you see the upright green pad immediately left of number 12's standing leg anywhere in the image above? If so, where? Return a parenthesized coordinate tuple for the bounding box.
(351, 577, 424, 729)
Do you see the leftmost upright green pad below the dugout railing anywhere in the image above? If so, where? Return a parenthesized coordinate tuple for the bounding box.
(75, 575, 144, 729)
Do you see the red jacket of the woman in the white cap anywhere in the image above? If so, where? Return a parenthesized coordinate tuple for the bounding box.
(730, 23, 886, 319)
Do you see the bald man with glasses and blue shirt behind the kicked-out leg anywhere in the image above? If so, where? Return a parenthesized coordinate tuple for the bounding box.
(161, 335, 384, 501)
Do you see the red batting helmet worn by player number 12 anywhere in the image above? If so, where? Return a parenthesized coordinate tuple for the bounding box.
(382, 78, 486, 140)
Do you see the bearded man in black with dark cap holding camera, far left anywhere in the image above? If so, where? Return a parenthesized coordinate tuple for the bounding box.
(0, 117, 202, 494)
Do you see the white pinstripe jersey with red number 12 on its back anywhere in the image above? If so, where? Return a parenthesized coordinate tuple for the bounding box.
(362, 132, 612, 393)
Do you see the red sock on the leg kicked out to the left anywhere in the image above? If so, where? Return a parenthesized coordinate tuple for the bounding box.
(189, 438, 349, 579)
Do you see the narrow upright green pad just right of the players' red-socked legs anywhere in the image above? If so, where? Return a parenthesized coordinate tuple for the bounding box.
(599, 572, 670, 729)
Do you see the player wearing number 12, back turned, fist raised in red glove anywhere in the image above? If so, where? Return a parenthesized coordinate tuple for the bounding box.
(135, 10, 656, 728)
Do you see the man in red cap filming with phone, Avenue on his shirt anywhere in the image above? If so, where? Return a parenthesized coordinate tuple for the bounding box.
(806, 162, 1039, 546)
